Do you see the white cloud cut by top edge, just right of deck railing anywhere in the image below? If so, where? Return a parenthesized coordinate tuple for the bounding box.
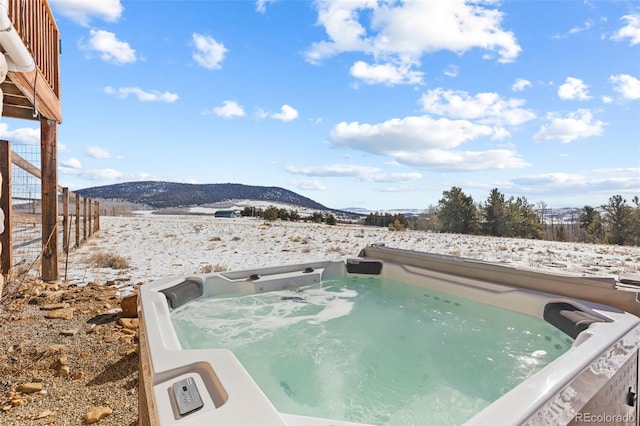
(49, 0, 123, 26)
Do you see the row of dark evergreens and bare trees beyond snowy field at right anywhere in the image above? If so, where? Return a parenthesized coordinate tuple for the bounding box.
(364, 186, 640, 246)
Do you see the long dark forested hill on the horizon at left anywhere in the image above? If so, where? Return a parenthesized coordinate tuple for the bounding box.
(74, 181, 333, 211)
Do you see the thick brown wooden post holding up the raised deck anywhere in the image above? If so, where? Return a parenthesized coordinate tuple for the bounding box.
(40, 118, 58, 281)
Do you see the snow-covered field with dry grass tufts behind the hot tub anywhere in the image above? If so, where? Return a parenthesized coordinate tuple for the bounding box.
(60, 212, 640, 292)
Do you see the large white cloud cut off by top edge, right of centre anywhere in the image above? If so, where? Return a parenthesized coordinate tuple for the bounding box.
(306, 0, 522, 84)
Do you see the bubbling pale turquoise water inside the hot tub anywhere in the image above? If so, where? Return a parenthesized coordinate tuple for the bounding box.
(171, 276, 573, 425)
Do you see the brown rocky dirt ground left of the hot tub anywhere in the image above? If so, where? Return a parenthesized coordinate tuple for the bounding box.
(0, 278, 138, 426)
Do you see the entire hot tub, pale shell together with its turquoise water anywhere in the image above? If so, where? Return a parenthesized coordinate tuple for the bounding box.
(138, 246, 640, 425)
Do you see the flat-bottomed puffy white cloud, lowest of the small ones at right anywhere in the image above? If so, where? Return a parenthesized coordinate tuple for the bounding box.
(533, 109, 607, 143)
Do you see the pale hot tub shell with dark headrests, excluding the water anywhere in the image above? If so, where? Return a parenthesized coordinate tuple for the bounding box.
(138, 246, 640, 426)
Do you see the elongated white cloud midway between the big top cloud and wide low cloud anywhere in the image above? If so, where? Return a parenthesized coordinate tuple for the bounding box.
(420, 88, 536, 126)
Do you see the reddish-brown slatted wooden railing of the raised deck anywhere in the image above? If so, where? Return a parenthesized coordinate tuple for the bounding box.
(8, 0, 60, 98)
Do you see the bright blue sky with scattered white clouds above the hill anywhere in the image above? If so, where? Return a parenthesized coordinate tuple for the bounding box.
(0, 0, 640, 210)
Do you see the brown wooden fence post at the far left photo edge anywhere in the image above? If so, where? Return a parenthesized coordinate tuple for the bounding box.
(0, 140, 13, 278)
